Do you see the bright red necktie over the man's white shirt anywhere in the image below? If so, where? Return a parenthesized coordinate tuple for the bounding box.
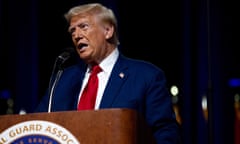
(78, 65, 102, 110)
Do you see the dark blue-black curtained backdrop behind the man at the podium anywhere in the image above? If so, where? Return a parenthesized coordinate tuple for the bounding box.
(0, 0, 240, 144)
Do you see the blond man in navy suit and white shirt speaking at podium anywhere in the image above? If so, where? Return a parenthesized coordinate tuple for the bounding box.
(36, 3, 179, 144)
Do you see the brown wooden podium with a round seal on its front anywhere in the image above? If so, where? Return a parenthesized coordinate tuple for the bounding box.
(0, 109, 156, 144)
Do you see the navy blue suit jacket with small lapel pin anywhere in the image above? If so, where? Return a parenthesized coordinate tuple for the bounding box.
(36, 54, 178, 144)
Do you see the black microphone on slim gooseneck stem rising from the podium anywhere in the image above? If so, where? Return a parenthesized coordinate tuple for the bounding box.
(48, 48, 74, 112)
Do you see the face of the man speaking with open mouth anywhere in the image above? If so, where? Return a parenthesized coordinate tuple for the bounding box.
(69, 14, 112, 63)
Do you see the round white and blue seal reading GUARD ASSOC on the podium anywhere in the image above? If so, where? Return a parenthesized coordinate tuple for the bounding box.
(0, 120, 80, 144)
